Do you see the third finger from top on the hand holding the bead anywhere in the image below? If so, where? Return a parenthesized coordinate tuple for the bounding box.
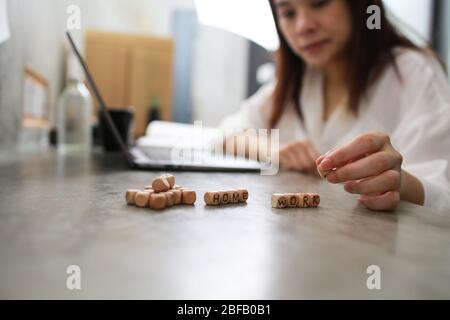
(344, 170, 401, 195)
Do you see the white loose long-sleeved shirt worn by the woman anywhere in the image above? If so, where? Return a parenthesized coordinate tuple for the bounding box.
(221, 49, 450, 208)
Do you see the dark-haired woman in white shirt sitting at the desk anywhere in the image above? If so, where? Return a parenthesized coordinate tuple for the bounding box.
(222, 0, 450, 210)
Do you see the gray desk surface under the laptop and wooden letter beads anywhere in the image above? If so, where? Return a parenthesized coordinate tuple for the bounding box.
(0, 151, 450, 299)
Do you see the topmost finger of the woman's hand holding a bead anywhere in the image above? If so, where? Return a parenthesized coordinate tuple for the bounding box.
(320, 133, 390, 170)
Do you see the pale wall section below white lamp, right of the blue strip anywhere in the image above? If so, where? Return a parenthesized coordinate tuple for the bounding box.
(193, 27, 249, 126)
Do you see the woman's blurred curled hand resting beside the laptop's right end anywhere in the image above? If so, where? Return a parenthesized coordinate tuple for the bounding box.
(280, 140, 319, 172)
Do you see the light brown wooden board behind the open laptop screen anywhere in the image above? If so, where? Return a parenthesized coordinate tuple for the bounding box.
(86, 31, 174, 137)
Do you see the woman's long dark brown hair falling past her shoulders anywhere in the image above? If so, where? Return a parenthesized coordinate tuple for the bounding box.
(269, 0, 421, 128)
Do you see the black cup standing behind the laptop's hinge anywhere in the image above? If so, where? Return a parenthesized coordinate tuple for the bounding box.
(98, 108, 134, 151)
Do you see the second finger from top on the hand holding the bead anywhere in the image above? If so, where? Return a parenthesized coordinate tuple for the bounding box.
(327, 151, 398, 183)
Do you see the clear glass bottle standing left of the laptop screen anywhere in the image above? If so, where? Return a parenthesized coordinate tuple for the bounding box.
(57, 55, 92, 153)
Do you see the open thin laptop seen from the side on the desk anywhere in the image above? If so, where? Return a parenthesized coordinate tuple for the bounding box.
(66, 32, 262, 172)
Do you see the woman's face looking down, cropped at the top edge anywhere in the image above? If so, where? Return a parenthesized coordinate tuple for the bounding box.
(273, 0, 352, 68)
